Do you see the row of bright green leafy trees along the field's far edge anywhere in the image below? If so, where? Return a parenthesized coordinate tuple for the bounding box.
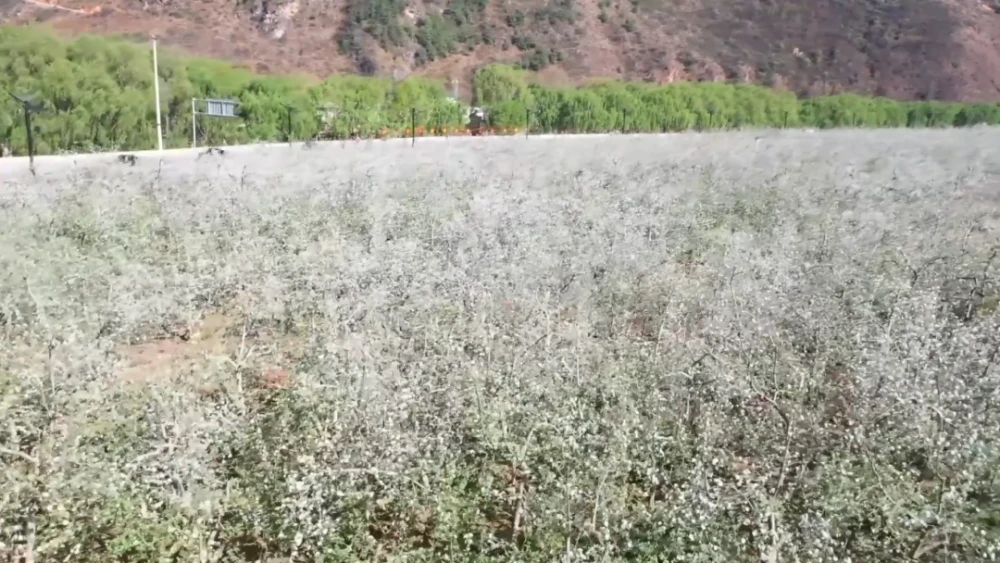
(0, 27, 1000, 154)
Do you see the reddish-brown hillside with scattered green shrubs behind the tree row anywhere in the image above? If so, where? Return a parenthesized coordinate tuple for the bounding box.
(0, 0, 1000, 101)
